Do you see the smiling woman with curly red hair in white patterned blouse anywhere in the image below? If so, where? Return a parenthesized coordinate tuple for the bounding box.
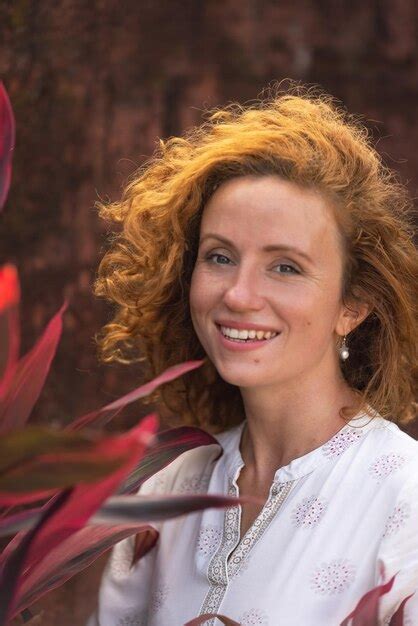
(89, 85, 418, 626)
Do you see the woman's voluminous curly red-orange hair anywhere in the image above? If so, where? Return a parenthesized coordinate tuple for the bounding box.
(95, 83, 418, 432)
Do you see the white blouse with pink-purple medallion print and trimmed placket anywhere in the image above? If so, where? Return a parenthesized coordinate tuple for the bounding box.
(87, 414, 418, 626)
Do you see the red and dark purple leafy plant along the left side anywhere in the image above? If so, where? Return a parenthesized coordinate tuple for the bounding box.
(0, 84, 258, 626)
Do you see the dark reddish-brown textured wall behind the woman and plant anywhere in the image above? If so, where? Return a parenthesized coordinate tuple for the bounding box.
(0, 0, 418, 626)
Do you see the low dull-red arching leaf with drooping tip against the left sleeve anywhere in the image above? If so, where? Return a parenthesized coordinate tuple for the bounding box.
(13, 523, 158, 616)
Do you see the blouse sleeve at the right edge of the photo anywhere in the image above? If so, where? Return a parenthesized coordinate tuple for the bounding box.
(377, 463, 418, 626)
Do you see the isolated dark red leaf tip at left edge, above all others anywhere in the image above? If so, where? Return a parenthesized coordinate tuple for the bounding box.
(0, 81, 15, 211)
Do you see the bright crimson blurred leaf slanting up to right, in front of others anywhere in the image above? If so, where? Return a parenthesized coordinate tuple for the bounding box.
(0, 414, 158, 585)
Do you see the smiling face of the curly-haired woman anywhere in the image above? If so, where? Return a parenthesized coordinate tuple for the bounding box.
(190, 176, 348, 387)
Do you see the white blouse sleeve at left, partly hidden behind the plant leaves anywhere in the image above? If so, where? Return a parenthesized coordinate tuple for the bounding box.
(86, 470, 164, 626)
